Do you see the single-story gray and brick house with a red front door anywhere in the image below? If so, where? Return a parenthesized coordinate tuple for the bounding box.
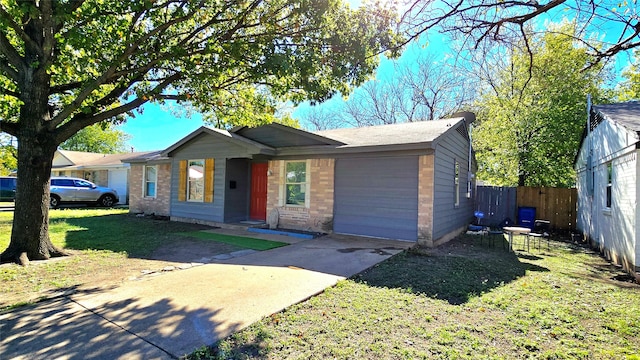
(129, 113, 476, 246)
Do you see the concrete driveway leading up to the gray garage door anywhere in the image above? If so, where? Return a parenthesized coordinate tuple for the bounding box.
(0, 233, 413, 360)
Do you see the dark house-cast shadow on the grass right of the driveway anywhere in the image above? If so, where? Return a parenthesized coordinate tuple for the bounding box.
(353, 239, 549, 305)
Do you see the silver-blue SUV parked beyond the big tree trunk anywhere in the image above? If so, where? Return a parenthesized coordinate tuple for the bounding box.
(50, 177, 118, 209)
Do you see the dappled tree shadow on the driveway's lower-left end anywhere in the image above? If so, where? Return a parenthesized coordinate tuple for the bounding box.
(0, 289, 241, 359)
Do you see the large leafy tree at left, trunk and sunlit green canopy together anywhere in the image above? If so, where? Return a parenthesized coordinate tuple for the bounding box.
(0, 0, 400, 264)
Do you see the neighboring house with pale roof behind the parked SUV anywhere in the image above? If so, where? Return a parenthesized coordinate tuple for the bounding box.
(51, 150, 156, 204)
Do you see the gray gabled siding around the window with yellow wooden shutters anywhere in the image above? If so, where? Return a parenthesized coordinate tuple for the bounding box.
(171, 134, 251, 222)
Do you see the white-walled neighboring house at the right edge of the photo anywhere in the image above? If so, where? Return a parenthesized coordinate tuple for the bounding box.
(575, 101, 640, 272)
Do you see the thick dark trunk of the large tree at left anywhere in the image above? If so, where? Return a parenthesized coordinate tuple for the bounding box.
(0, 37, 65, 265)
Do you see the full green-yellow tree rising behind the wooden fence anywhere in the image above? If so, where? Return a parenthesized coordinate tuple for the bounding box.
(473, 25, 611, 187)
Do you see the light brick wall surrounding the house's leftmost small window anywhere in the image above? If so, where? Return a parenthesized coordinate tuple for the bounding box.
(129, 163, 171, 216)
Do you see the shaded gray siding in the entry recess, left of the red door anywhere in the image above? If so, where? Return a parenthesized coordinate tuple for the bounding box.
(224, 159, 251, 222)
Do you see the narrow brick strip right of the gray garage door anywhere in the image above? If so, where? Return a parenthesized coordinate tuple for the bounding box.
(418, 154, 435, 247)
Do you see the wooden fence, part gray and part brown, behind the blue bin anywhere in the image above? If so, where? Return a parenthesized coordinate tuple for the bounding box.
(476, 186, 577, 230)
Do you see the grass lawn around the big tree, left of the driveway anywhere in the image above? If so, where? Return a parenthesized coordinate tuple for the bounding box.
(0, 208, 243, 311)
